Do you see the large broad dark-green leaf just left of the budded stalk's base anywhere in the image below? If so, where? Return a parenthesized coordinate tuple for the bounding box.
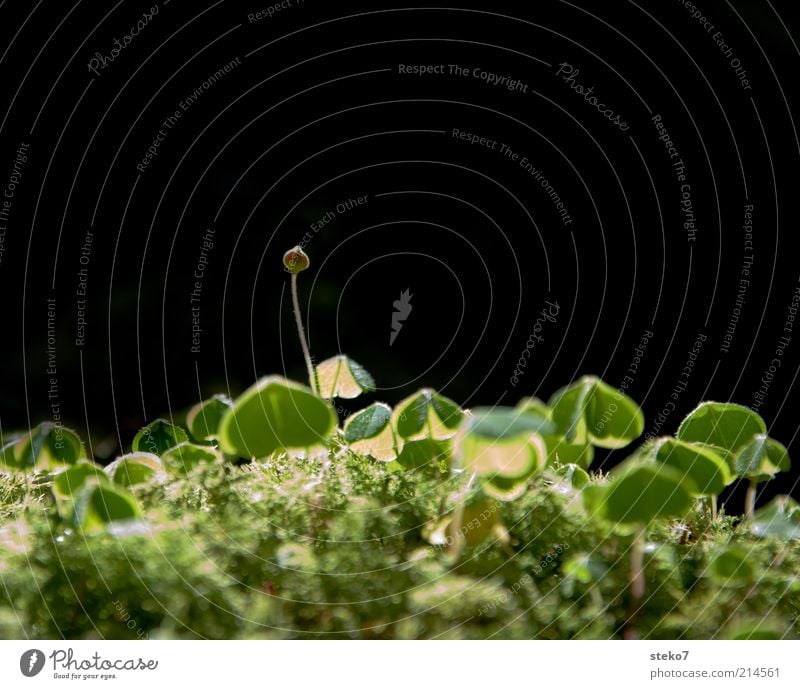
(219, 376, 337, 458)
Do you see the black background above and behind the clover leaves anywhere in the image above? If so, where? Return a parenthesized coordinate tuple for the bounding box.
(0, 0, 800, 503)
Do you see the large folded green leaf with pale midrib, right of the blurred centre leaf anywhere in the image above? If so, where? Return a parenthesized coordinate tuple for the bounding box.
(549, 376, 644, 449)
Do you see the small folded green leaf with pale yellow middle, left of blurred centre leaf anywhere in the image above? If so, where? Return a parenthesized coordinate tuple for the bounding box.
(392, 388, 464, 440)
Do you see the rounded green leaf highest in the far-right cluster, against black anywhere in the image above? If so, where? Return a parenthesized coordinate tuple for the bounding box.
(676, 402, 767, 453)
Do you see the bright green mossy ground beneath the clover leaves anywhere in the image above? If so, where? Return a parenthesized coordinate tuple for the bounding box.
(0, 450, 800, 639)
